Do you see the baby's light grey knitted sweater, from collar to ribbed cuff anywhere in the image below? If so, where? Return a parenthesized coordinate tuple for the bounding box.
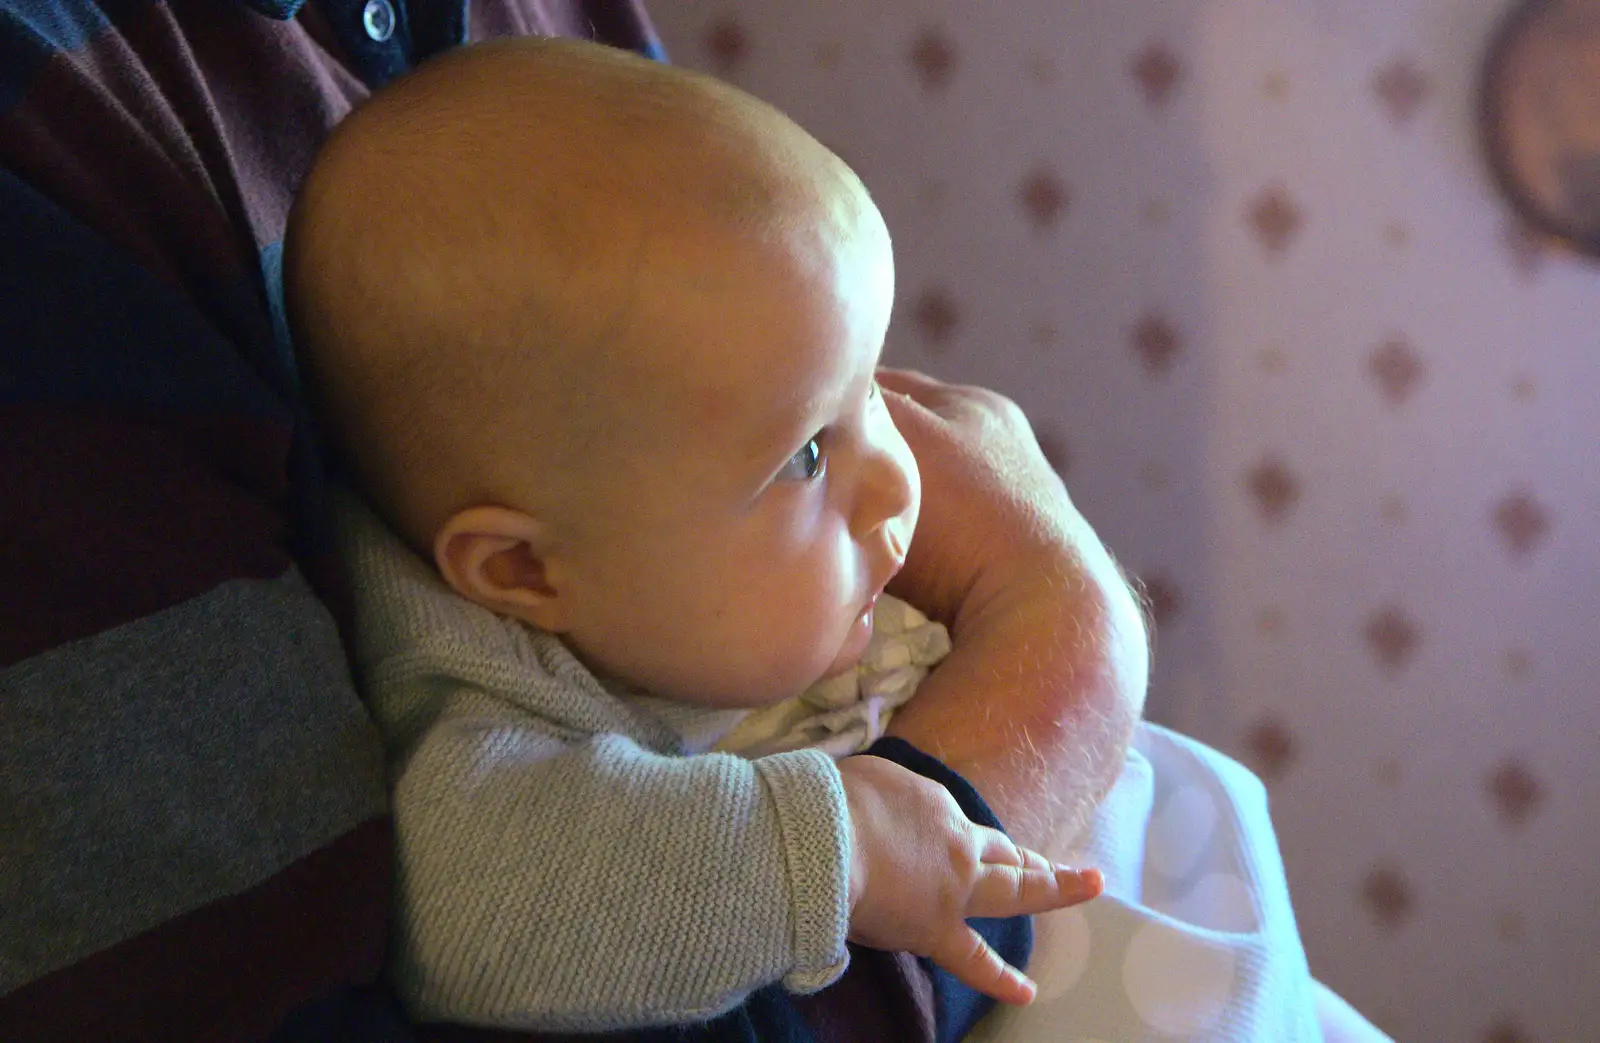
(341, 498, 850, 1032)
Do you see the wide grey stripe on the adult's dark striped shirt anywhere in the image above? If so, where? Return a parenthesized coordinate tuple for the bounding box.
(0, 573, 384, 993)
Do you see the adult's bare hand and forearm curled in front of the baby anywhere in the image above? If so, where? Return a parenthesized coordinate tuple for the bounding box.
(878, 370, 1149, 856)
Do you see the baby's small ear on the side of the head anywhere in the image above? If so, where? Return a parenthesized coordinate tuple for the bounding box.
(434, 507, 566, 633)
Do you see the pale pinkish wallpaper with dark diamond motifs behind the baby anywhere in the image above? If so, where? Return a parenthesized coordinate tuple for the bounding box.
(650, 0, 1600, 1043)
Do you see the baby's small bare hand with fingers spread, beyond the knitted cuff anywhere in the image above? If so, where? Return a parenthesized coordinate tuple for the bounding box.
(838, 757, 1104, 1005)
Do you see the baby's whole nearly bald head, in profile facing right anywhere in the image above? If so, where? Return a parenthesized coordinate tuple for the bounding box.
(285, 40, 920, 705)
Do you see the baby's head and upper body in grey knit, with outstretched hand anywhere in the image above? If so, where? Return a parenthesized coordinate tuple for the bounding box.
(285, 32, 1099, 1032)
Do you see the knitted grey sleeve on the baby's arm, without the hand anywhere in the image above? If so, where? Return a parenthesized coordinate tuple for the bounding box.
(395, 694, 850, 1032)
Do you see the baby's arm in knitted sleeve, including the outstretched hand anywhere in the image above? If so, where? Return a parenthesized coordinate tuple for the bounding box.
(395, 693, 1099, 1032)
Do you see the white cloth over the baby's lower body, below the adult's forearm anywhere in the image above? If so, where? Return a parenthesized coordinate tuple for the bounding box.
(966, 725, 1322, 1043)
